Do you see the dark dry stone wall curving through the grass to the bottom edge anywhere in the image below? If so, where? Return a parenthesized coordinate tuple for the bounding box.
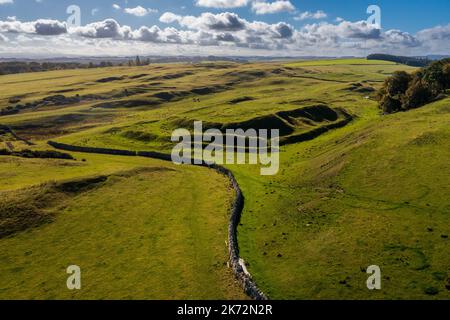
(47, 141, 268, 300)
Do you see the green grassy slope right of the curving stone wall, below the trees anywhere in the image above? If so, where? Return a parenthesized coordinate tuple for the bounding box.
(233, 99, 450, 299)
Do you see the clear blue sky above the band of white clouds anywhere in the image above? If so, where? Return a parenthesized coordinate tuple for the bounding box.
(0, 0, 450, 33)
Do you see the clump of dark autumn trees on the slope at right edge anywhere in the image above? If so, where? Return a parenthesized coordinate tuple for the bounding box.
(378, 58, 450, 113)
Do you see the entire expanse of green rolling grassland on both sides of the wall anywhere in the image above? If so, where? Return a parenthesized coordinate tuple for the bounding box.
(0, 59, 450, 299)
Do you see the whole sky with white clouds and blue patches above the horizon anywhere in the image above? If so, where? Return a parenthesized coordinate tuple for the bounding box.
(0, 0, 450, 57)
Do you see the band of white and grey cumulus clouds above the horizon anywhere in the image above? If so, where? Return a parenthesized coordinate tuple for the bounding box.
(0, 12, 450, 55)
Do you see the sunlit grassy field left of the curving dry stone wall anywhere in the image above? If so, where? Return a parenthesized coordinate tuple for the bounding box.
(0, 154, 245, 299)
